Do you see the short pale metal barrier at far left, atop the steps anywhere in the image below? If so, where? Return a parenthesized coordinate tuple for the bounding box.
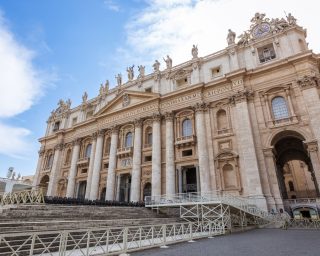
(0, 190, 44, 205)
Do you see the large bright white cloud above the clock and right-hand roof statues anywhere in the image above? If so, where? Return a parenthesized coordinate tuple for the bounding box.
(118, 0, 320, 70)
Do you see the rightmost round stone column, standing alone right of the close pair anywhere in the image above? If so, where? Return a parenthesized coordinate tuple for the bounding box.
(195, 103, 211, 192)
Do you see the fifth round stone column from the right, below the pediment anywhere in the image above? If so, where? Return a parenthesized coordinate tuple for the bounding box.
(106, 127, 118, 200)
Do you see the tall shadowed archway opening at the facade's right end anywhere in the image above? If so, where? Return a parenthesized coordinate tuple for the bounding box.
(272, 131, 319, 199)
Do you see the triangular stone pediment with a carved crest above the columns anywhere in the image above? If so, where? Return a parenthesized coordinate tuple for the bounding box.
(95, 90, 159, 116)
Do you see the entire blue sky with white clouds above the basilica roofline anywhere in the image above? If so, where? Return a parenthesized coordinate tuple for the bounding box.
(0, 0, 320, 176)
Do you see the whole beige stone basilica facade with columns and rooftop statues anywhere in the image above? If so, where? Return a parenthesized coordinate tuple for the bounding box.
(33, 13, 320, 214)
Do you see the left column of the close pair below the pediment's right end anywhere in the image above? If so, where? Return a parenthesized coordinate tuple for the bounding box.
(151, 114, 161, 196)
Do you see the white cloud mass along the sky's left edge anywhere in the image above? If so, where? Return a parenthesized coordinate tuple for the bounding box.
(0, 10, 49, 158)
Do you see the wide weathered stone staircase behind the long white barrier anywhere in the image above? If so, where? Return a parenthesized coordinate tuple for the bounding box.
(0, 204, 181, 234)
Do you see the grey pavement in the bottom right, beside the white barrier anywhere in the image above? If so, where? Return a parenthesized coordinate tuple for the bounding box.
(130, 229, 320, 256)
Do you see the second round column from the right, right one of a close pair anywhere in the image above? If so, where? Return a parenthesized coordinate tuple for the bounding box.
(166, 113, 176, 195)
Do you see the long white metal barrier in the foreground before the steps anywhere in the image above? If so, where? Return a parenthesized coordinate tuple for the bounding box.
(0, 222, 226, 256)
